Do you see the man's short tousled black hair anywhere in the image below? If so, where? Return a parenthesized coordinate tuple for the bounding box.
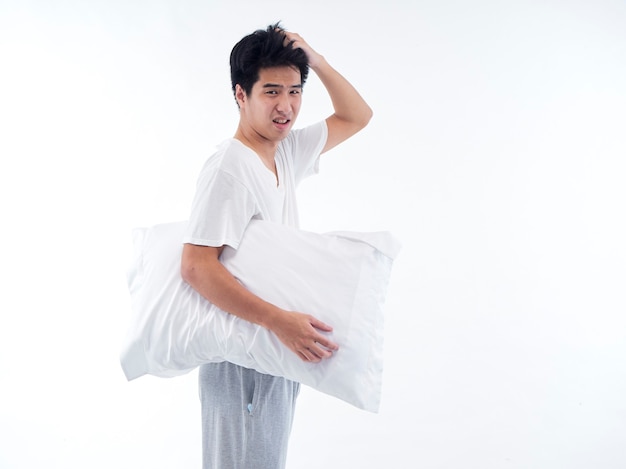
(230, 22, 309, 101)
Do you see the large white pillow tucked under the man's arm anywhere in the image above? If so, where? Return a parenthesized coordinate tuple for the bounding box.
(121, 220, 399, 412)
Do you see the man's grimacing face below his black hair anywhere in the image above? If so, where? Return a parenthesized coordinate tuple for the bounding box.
(237, 67, 302, 142)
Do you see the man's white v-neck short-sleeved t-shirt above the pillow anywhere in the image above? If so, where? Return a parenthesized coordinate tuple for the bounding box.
(183, 121, 328, 249)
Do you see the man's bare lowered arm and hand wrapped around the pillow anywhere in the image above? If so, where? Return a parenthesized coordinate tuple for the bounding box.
(181, 244, 338, 362)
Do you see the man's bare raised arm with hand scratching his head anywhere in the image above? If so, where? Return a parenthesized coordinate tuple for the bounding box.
(285, 31, 373, 153)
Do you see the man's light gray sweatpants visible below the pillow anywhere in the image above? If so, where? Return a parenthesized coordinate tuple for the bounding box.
(199, 362, 300, 469)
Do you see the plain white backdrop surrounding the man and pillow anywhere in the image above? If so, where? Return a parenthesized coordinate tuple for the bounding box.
(0, 0, 626, 469)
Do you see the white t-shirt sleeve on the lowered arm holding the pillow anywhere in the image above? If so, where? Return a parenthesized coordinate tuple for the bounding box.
(183, 168, 257, 249)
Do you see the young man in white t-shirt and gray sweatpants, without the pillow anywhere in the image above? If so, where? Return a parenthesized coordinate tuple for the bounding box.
(181, 25, 372, 469)
